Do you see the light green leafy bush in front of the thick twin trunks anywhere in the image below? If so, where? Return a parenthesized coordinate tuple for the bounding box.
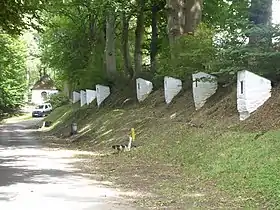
(158, 24, 216, 79)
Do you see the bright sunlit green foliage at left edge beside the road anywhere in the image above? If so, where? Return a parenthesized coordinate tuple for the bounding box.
(0, 34, 27, 112)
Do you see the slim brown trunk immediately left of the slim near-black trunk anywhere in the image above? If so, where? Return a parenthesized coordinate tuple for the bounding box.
(133, 0, 145, 78)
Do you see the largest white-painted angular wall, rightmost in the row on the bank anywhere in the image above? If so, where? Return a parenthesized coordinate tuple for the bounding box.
(237, 70, 272, 120)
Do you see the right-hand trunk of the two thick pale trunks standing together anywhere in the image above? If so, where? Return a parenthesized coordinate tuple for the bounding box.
(184, 0, 203, 34)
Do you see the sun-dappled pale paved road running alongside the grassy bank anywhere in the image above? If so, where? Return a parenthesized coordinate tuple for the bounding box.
(0, 120, 140, 210)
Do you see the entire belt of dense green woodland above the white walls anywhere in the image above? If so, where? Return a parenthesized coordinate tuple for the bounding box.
(0, 0, 280, 111)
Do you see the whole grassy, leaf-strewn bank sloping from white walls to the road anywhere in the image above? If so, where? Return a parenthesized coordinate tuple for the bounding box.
(42, 87, 280, 209)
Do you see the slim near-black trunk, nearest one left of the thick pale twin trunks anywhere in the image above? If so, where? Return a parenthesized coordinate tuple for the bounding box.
(150, 2, 159, 74)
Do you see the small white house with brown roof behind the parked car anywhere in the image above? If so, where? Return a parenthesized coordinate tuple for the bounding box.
(31, 75, 58, 104)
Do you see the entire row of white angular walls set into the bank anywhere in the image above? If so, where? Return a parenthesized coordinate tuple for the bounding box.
(72, 70, 271, 120)
